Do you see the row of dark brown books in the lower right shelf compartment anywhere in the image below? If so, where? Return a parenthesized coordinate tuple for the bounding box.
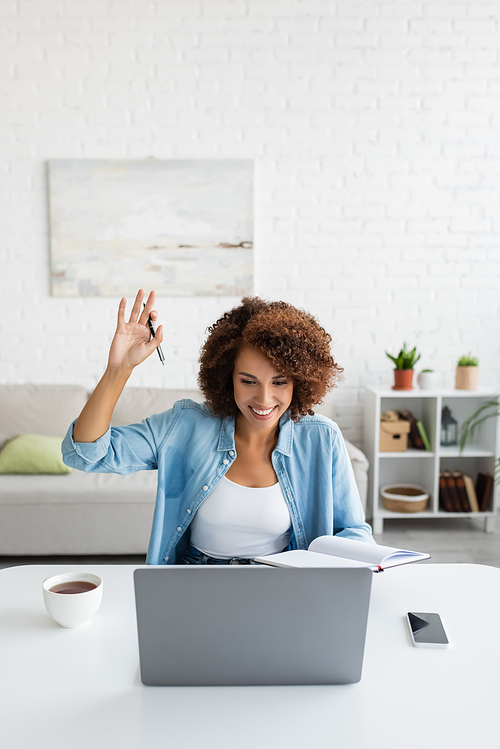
(439, 471, 493, 512)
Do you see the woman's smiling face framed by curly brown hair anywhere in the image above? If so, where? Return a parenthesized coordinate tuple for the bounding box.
(233, 346, 293, 431)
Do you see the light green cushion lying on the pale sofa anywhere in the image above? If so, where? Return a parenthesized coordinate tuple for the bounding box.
(0, 434, 71, 473)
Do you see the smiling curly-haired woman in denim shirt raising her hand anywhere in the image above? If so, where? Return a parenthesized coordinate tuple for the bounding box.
(63, 290, 373, 564)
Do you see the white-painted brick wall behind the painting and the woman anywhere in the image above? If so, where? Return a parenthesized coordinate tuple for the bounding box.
(0, 0, 500, 442)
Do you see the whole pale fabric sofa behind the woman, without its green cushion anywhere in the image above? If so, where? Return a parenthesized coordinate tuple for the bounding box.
(0, 385, 368, 556)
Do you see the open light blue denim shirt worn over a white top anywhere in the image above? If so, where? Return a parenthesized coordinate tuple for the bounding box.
(62, 400, 373, 564)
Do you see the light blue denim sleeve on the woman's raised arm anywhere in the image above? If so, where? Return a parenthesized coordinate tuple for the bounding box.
(62, 411, 170, 474)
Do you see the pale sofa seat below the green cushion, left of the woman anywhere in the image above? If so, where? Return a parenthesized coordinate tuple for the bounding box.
(0, 471, 157, 555)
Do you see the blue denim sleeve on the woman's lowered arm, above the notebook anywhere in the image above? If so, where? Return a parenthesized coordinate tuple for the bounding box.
(332, 430, 375, 543)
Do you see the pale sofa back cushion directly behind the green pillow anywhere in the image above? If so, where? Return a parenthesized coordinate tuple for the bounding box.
(0, 385, 88, 448)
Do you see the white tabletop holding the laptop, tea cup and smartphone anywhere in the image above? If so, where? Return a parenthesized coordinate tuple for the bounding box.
(0, 564, 500, 749)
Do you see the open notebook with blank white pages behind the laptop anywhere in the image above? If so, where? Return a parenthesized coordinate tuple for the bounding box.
(254, 536, 430, 572)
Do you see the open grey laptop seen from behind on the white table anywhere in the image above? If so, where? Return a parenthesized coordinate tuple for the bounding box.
(134, 565, 373, 686)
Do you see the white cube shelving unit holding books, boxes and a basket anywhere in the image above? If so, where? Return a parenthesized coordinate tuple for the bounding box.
(364, 388, 500, 534)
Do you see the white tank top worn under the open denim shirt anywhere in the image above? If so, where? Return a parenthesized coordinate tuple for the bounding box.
(191, 476, 291, 559)
